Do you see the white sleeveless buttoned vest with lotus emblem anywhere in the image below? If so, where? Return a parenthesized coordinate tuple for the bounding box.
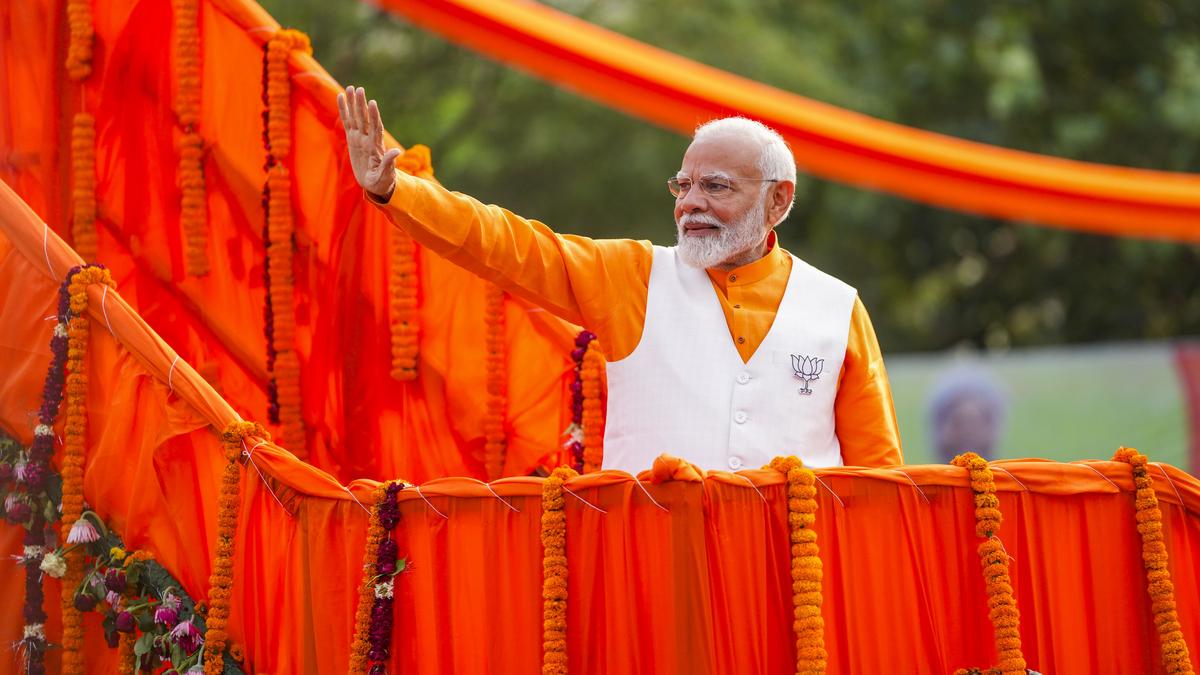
(604, 246, 857, 473)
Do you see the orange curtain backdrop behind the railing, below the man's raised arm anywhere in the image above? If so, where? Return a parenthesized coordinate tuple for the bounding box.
(0, 0, 576, 480)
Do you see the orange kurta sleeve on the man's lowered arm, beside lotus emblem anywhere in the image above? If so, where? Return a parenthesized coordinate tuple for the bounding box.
(834, 298, 904, 466)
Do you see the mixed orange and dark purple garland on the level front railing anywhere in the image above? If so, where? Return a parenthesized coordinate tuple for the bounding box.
(349, 480, 408, 675)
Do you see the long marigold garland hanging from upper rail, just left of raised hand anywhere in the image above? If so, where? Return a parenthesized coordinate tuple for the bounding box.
(263, 29, 312, 451)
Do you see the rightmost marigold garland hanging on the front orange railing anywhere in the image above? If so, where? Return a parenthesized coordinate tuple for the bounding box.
(1112, 448, 1193, 673)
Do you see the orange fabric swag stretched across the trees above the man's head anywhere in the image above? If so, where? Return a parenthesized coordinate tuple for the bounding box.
(376, 0, 1200, 241)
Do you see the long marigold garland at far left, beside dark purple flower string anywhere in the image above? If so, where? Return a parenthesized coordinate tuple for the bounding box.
(61, 265, 113, 674)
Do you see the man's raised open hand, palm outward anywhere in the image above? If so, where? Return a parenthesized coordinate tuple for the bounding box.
(337, 86, 403, 199)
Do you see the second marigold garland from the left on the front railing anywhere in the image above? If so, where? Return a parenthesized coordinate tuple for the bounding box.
(204, 422, 270, 675)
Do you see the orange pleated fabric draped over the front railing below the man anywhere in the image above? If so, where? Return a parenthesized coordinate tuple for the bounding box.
(0, 184, 1200, 675)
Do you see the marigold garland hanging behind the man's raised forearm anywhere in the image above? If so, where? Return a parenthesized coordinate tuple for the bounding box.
(389, 145, 433, 382)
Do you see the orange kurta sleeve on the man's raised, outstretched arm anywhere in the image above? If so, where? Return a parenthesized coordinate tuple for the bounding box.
(368, 172, 654, 360)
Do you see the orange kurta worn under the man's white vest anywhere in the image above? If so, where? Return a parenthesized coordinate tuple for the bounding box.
(368, 172, 904, 466)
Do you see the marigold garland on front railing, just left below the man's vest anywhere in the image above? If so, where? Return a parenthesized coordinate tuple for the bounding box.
(541, 466, 578, 675)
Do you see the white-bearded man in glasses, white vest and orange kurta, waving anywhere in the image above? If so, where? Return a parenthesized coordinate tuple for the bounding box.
(338, 88, 902, 473)
